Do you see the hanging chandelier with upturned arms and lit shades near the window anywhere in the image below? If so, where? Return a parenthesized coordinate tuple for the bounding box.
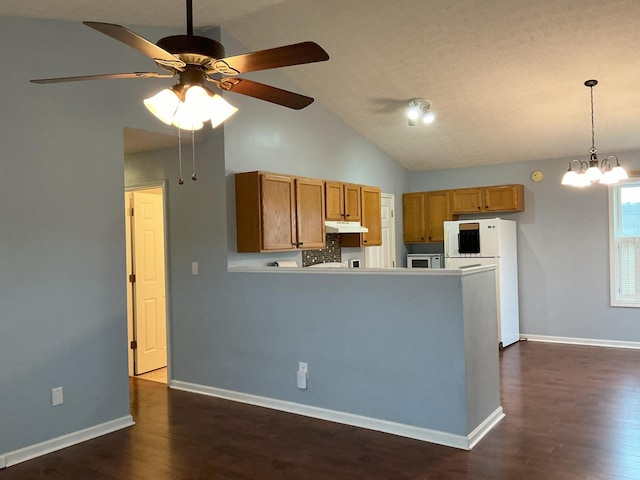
(562, 80, 629, 187)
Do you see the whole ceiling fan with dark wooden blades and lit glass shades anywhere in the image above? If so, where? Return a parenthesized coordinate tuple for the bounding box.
(31, 0, 329, 180)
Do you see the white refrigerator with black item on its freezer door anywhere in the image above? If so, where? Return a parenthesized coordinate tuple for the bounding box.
(444, 218, 520, 348)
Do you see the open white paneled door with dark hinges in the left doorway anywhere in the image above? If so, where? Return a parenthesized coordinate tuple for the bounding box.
(132, 188, 167, 375)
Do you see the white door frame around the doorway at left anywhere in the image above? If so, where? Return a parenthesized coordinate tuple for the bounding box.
(124, 180, 173, 385)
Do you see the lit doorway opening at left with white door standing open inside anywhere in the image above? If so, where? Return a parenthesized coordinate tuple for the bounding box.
(125, 183, 168, 383)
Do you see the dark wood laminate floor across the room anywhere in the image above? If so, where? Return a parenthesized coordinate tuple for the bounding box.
(0, 342, 640, 480)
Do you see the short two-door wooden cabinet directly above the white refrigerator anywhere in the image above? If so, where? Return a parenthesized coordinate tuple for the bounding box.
(451, 184, 524, 213)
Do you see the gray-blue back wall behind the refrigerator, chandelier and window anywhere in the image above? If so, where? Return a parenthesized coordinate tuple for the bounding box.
(410, 152, 640, 342)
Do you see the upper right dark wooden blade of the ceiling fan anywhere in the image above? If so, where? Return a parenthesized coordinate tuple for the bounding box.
(221, 42, 329, 73)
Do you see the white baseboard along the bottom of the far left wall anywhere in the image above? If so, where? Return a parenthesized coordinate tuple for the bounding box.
(0, 415, 135, 468)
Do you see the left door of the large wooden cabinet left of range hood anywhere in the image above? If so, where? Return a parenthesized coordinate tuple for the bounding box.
(260, 174, 296, 250)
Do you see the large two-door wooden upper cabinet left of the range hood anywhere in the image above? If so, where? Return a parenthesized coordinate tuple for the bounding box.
(235, 172, 325, 253)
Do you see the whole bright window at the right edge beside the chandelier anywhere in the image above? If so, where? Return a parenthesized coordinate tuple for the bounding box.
(610, 179, 640, 307)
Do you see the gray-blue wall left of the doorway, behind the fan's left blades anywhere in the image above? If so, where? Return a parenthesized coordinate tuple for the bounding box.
(0, 17, 185, 454)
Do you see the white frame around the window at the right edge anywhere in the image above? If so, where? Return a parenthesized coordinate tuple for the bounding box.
(609, 176, 640, 308)
